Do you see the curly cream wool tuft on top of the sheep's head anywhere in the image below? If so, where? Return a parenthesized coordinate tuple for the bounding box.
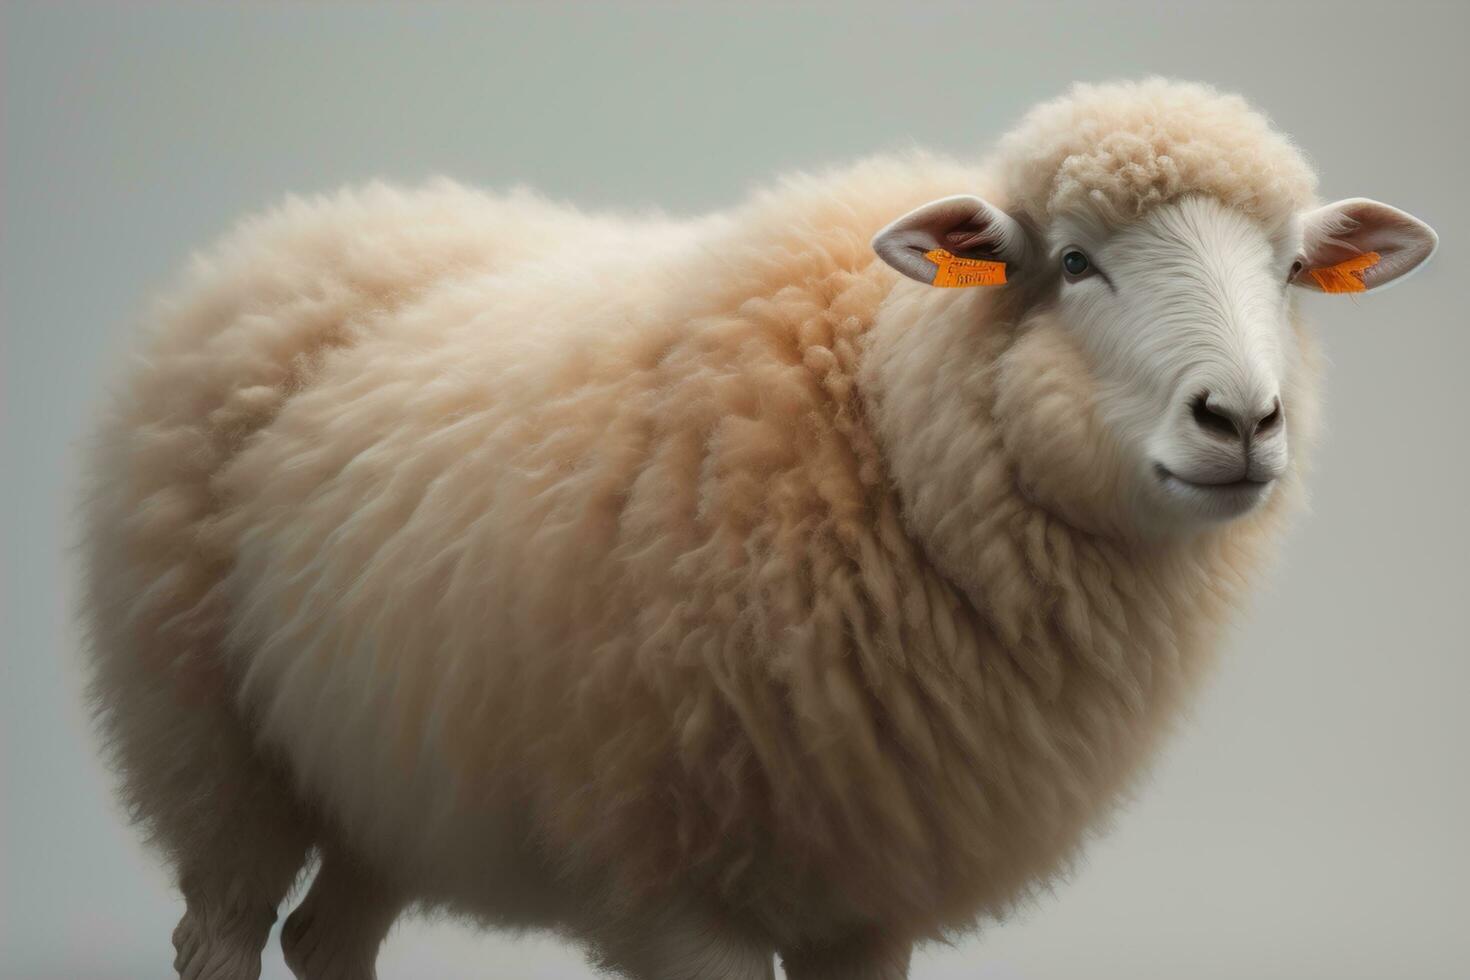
(994, 78, 1317, 226)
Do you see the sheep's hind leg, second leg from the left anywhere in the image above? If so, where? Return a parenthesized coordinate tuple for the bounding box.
(281, 848, 403, 980)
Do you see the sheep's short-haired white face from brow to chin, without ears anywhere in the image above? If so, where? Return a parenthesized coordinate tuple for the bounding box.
(1048, 197, 1299, 527)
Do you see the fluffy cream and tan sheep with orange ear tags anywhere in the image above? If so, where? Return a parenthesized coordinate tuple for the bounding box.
(82, 79, 1436, 980)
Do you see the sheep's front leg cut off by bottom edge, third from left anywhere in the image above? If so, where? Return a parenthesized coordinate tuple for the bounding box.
(585, 911, 776, 980)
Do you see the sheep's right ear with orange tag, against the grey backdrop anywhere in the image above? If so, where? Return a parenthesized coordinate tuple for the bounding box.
(1292, 197, 1439, 292)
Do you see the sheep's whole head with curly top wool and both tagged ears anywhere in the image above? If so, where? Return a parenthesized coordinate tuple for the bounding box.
(873, 82, 1436, 532)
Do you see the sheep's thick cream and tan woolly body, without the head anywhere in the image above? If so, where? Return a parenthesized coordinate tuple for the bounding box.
(90, 80, 1328, 976)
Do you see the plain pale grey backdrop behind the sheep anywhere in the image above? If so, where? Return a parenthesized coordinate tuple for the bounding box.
(0, 0, 1470, 980)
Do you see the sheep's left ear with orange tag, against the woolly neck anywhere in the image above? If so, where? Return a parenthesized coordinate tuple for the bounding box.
(873, 194, 1026, 287)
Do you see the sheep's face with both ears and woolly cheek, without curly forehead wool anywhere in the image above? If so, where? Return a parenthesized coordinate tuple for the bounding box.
(875, 195, 1436, 533)
